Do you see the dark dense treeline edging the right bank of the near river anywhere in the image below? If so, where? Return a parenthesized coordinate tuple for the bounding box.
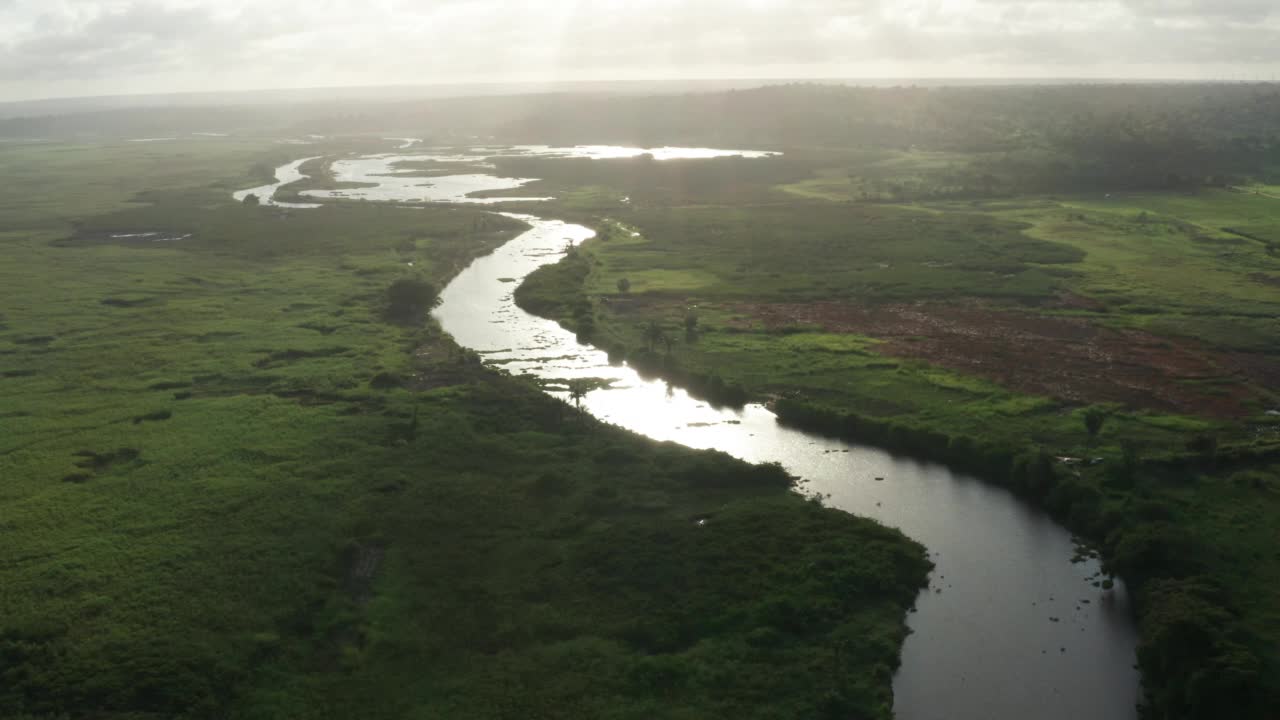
(774, 398, 1280, 720)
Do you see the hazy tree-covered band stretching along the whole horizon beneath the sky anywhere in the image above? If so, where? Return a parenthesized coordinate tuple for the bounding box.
(15, 85, 1280, 193)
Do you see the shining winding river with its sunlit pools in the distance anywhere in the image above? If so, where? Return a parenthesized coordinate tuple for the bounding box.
(240, 146, 1139, 720)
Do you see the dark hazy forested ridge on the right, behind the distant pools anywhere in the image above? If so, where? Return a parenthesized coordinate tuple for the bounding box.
(491, 85, 1280, 196)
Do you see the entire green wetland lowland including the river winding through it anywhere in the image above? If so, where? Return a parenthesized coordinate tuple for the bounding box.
(0, 81, 1280, 720)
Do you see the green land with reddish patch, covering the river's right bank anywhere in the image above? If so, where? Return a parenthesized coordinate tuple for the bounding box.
(517, 159, 1280, 717)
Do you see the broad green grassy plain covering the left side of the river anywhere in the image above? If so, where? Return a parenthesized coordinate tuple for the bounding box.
(0, 141, 928, 720)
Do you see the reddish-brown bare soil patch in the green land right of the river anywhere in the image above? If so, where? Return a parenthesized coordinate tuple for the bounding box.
(733, 302, 1276, 418)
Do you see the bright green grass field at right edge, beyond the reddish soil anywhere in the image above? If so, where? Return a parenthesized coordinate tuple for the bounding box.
(957, 191, 1280, 354)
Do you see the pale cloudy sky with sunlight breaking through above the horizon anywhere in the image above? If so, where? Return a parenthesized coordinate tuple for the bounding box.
(0, 0, 1280, 100)
